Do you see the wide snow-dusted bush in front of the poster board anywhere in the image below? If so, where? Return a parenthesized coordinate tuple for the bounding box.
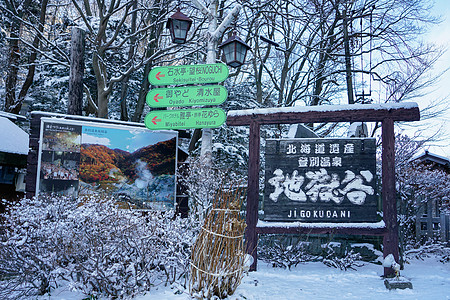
(0, 196, 197, 298)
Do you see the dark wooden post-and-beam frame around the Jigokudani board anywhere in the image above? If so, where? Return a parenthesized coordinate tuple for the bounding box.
(227, 103, 420, 276)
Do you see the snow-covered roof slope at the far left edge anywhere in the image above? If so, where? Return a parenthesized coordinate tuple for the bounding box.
(0, 117, 28, 155)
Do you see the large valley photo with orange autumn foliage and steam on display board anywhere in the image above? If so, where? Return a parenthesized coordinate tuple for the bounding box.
(79, 126, 177, 209)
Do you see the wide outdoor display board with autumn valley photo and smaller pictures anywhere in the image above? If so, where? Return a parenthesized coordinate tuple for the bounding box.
(36, 118, 178, 210)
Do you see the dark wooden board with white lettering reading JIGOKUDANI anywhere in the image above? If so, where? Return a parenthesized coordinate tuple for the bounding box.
(264, 138, 377, 222)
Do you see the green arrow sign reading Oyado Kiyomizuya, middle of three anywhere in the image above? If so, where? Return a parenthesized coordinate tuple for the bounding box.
(146, 85, 228, 107)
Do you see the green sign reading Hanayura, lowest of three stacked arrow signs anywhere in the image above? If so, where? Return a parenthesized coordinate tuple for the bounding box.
(144, 108, 226, 130)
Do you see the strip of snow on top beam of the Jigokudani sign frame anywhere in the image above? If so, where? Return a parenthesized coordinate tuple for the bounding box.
(228, 102, 418, 117)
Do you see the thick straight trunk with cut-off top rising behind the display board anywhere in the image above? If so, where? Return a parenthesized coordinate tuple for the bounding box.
(67, 27, 85, 115)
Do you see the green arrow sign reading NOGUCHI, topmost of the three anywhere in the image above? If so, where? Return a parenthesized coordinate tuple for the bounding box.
(148, 63, 229, 85)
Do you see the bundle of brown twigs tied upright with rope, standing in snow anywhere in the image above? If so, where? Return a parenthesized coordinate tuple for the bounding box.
(190, 182, 246, 299)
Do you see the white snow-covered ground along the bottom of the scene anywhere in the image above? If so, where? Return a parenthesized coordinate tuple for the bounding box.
(42, 258, 450, 300)
